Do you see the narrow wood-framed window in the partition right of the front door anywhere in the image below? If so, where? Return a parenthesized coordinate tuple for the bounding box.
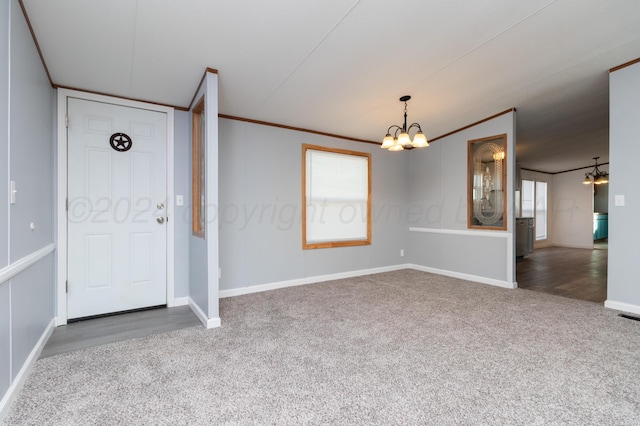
(191, 97, 206, 238)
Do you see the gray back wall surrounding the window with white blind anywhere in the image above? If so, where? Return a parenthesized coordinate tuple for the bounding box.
(219, 119, 409, 290)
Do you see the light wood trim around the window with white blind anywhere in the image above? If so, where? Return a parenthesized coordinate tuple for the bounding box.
(302, 144, 371, 250)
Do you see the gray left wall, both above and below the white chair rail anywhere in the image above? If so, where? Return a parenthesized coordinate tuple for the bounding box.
(0, 0, 54, 406)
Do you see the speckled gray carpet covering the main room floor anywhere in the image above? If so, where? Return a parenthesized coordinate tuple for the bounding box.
(6, 270, 640, 425)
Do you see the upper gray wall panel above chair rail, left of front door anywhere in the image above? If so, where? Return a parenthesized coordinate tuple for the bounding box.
(9, 4, 54, 262)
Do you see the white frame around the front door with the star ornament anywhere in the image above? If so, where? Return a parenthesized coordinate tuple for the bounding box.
(55, 88, 176, 326)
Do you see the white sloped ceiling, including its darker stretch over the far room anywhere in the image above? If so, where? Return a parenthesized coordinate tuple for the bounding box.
(22, 0, 640, 172)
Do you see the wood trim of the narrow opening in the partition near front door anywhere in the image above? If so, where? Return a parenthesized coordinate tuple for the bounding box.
(191, 96, 206, 238)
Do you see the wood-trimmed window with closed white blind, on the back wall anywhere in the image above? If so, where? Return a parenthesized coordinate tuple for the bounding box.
(302, 145, 371, 249)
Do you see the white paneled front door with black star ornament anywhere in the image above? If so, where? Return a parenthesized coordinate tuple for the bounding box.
(67, 97, 167, 319)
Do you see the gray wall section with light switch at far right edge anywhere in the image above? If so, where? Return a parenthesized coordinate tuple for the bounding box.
(607, 63, 640, 312)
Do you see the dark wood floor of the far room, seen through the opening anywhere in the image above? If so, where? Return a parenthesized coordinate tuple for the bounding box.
(516, 242, 609, 303)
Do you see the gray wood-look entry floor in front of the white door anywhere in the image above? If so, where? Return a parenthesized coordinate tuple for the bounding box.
(40, 306, 202, 358)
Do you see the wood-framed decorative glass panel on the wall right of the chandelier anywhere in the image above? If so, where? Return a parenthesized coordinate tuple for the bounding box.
(467, 134, 507, 230)
